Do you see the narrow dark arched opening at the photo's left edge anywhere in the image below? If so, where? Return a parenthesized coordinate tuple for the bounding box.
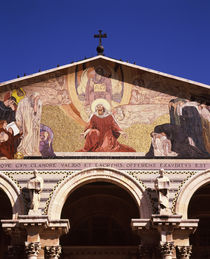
(0, 188, 12, 258)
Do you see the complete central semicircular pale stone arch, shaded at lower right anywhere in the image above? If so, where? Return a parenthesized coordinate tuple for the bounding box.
(48, 168, 152, 220)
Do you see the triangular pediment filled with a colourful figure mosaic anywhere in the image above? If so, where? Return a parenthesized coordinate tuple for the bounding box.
(0, 55, 210, 158)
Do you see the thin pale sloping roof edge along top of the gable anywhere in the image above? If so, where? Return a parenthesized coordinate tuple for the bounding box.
(0, 55, 210, 89)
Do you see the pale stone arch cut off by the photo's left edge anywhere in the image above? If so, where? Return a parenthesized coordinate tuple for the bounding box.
(0, 172, 24, 219)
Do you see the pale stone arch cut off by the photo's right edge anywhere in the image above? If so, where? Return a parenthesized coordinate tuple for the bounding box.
(175, 170, 210, 219)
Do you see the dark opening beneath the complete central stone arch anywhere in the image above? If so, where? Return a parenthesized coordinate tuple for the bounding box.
(61, 182, 140, 259)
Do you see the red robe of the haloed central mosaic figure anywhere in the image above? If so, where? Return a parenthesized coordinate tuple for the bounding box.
(79, 114, 136, 152)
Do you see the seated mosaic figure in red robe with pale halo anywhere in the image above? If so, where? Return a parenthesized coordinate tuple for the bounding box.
(79, 99, 135, 152)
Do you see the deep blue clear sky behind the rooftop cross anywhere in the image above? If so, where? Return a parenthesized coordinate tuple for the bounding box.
(0, 0, 210, 84)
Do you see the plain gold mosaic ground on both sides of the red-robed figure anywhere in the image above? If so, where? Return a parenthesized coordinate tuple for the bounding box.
(41, 105, 169, 153)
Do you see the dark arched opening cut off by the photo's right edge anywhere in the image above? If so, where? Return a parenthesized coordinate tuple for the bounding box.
(188, 183, 210, 259)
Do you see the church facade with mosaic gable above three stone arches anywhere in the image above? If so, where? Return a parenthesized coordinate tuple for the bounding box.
(0, 55, 210, 259)
